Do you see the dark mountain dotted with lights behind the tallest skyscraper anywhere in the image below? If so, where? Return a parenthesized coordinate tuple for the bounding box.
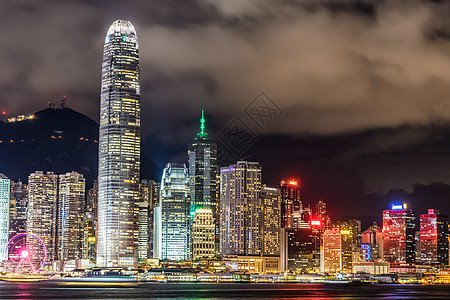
(0, 108, 160, 186)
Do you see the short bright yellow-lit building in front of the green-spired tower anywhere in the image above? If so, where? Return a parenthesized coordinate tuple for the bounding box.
(192, 208, 216, 260)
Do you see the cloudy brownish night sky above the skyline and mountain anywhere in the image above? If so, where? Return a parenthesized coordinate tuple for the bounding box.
(0, 0, 450, 223)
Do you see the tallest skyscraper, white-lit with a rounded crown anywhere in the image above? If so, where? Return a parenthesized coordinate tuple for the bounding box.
(97, 20, 141, 266)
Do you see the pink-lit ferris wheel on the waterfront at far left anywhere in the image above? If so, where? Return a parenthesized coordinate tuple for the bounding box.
(5, 233, 47, 273)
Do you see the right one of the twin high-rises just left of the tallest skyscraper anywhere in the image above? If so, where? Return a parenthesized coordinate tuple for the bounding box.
(56, 172, 86, 261)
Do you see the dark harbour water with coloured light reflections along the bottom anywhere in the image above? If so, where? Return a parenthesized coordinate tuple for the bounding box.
(0, 281, 450, 299)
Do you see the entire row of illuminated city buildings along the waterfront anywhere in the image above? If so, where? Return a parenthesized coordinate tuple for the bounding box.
(0, 20, 449, 273)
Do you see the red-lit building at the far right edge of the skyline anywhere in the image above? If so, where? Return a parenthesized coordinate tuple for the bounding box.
(420, 209, 449, 265)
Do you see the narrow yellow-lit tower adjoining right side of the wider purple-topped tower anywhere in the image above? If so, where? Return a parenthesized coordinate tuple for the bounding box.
(261, 187, 281, 256)
